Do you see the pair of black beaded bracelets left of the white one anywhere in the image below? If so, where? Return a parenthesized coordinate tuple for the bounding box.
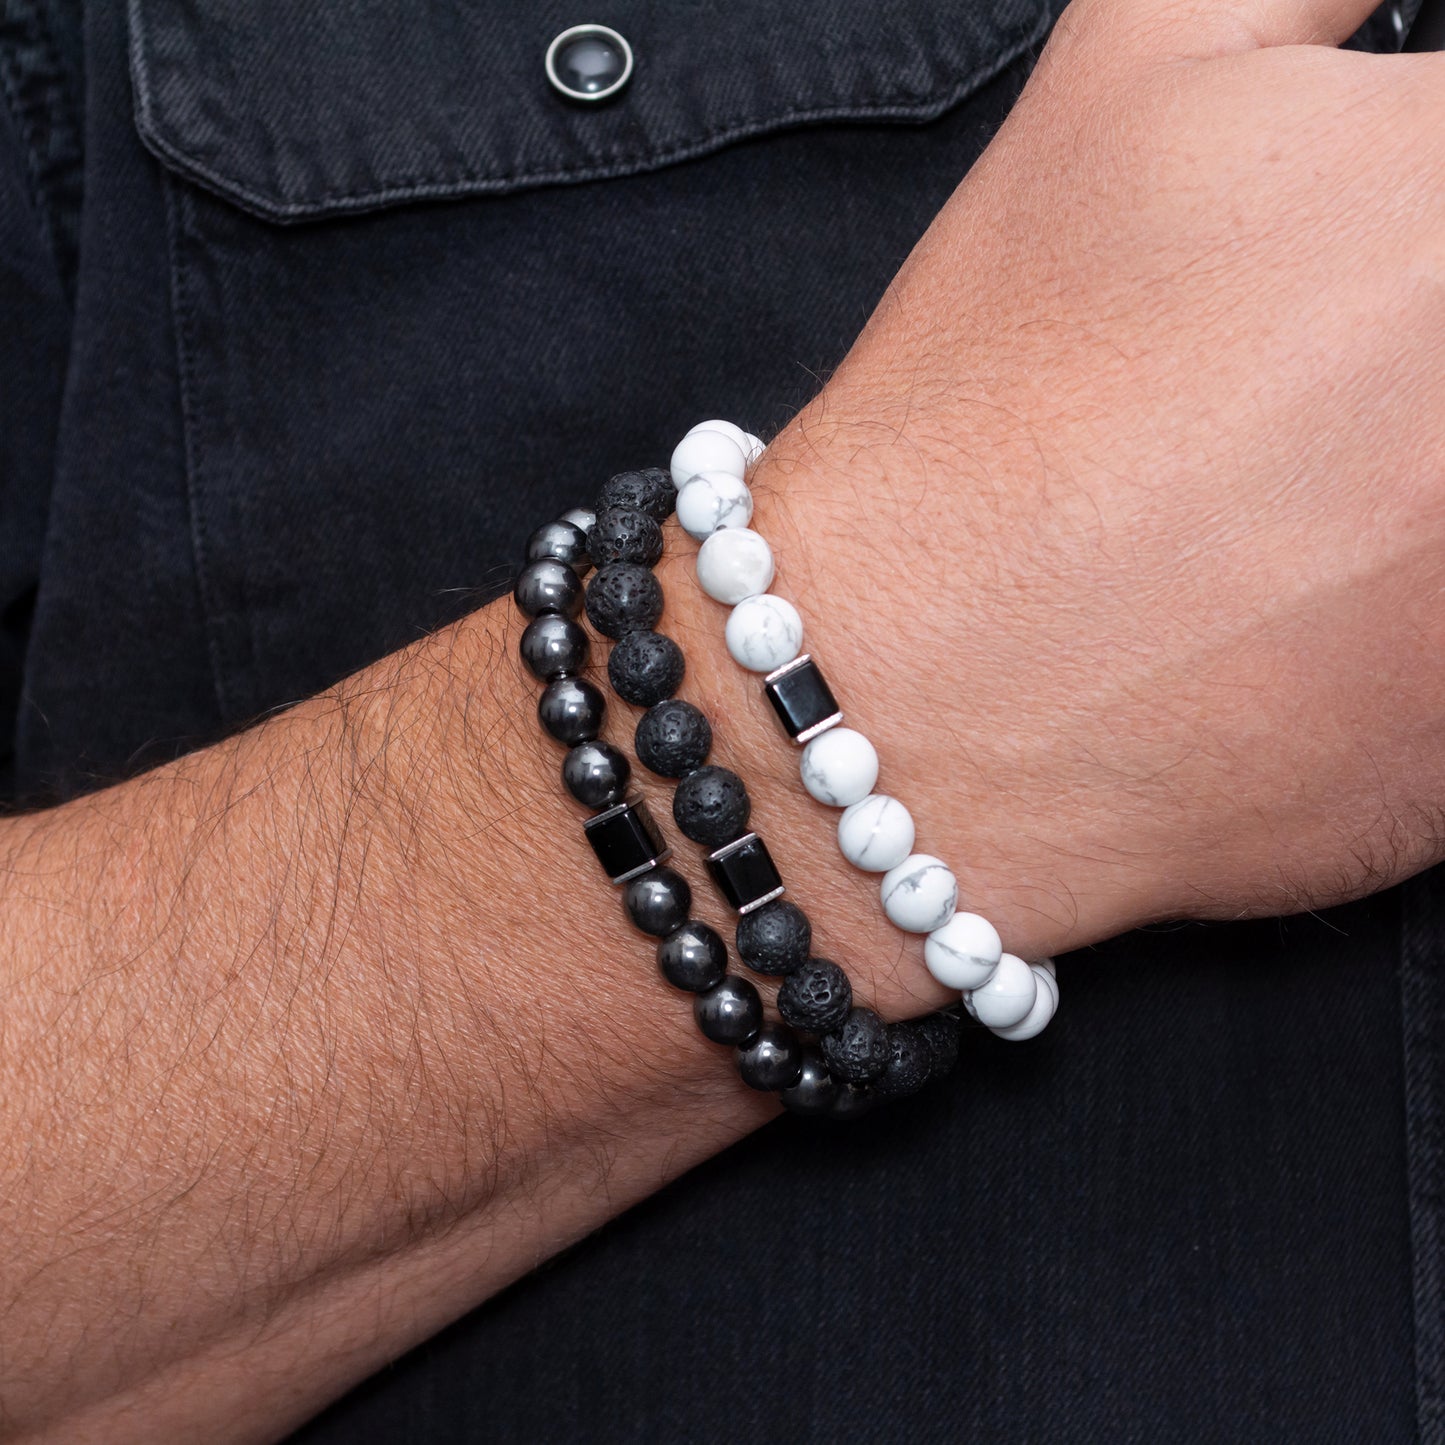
(514, 462, 958, 1117)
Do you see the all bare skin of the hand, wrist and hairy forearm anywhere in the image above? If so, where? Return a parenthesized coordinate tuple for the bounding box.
(0, 0, 1445, 1442)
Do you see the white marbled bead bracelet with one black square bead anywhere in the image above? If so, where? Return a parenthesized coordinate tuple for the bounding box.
(672, 420, 1059, 1040)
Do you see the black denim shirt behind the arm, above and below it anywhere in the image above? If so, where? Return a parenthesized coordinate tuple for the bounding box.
(0, 0, 1445, 1445)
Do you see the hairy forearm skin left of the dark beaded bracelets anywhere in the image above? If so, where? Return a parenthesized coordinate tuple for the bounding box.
(0, 603, 775, 1441)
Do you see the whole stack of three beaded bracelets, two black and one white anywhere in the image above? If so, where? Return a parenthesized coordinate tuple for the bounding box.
(514, 422, 1058, 1117)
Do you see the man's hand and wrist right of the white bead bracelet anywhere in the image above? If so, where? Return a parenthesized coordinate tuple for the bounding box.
(705, 0, 1445, 1003)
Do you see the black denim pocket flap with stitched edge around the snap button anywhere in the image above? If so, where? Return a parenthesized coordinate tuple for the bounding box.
(130, 0, 1052, 221)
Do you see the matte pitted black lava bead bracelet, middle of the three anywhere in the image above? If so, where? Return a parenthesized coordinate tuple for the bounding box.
(585, 459, 957, 1113)
